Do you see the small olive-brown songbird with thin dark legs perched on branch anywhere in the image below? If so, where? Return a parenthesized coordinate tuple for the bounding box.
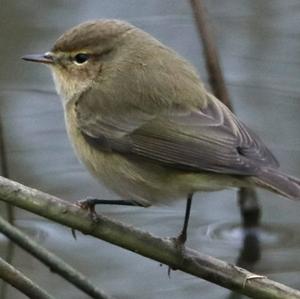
(23, 20, 300, 243)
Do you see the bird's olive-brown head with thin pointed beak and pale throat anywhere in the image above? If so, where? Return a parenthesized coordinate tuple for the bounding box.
(23, 20, 135, 101)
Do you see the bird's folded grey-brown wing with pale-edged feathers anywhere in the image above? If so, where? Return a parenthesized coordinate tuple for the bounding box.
(76, 88, 278, 175)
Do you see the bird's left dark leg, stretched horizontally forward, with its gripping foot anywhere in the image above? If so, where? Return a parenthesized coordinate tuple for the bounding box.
(76, 197, 143, 222)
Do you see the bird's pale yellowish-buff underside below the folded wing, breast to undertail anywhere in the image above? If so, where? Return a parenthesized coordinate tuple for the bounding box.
(67, 109, 245, 206)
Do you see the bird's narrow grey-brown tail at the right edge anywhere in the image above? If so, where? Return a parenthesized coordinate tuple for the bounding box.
(254, 168, 300, 200)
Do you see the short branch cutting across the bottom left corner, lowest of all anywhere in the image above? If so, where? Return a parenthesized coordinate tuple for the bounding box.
(0, 258, 54, 299)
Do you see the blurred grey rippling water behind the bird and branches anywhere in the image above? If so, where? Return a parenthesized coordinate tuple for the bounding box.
(0, 0, 300, 299)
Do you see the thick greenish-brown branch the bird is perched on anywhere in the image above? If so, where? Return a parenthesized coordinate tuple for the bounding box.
(0, 177, 300, 299)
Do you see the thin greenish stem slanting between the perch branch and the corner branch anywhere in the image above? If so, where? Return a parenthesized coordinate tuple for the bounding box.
(0, 217, 111, 299)
